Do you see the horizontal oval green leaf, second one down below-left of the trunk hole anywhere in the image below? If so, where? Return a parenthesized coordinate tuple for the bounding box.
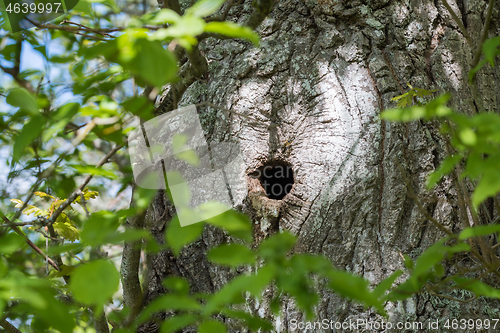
(208, 244, 255, 267)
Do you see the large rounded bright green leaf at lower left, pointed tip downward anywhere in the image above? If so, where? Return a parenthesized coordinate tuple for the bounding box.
(69, 260, 120, 314)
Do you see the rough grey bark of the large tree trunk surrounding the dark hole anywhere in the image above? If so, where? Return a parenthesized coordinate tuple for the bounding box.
(139, 0, 500, 332)
